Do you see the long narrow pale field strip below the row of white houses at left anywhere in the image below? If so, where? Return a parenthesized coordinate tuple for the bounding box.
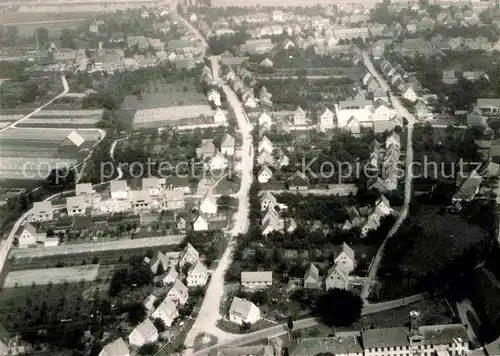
(9, 235, 185, 260)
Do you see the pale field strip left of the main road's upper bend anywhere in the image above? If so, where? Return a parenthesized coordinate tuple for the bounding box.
(133, 105, 214, 128)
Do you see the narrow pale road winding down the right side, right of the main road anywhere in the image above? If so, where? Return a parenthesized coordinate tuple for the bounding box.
(361, 52, 417, 301)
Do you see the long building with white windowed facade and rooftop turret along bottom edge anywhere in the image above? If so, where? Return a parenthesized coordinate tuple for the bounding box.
(211, 311, 470, 356)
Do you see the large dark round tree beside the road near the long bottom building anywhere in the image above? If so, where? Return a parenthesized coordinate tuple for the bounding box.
(315, 288, 363, 326)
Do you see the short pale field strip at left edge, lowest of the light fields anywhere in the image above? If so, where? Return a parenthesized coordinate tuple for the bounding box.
(3, 265, 99, 288)
